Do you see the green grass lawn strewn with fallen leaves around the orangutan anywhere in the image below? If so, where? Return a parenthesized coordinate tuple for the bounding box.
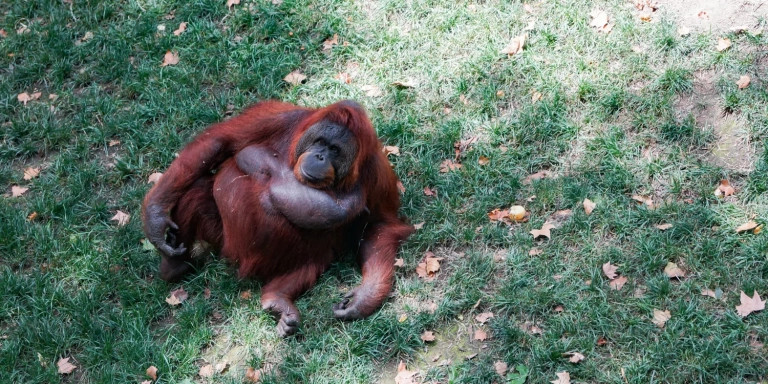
(0, 0, 768, 383)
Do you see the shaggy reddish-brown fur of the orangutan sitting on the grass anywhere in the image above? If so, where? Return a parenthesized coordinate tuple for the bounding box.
(143, 101, 412, 333)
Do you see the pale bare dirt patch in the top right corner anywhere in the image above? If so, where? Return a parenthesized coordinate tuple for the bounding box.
(659, 0, 768, 33)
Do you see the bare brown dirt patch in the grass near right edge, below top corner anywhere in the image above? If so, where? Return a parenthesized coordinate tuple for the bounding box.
(675, 70, 757, 174)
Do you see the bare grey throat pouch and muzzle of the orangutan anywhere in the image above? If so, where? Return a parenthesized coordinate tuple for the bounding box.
(235, 145, 365, 229)
